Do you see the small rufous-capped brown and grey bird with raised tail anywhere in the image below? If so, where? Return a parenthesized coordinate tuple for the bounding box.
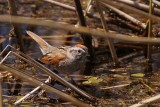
(26, 31, 89, 75)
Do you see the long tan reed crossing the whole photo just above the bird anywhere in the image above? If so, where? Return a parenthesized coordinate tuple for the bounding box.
(0, 15, 160, 44)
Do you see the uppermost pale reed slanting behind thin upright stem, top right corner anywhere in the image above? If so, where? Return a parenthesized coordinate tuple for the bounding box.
(116, 0, 160, 15)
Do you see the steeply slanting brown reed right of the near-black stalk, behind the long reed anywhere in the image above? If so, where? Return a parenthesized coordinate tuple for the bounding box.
(95, 0, 119, 64)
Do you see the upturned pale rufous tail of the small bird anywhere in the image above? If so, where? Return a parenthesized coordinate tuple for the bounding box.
(26, 31, 52, 55)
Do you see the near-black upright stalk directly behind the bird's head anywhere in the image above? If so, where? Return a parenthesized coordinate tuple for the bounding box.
(74, 0, 94, 75)
